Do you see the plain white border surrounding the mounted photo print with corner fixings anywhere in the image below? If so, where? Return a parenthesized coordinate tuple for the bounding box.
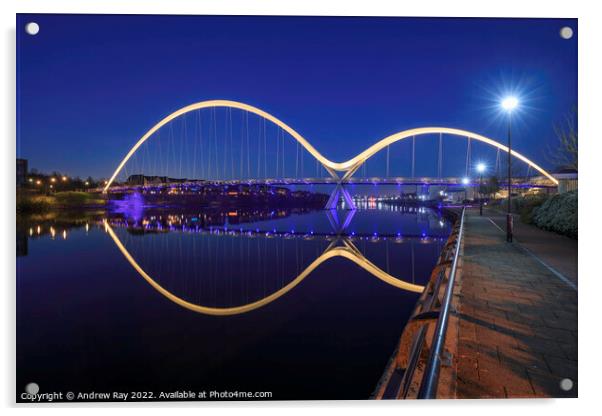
(0, 0, 602, 416)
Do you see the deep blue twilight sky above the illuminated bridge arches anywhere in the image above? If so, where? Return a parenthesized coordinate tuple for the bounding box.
(17, 14, 577, 177)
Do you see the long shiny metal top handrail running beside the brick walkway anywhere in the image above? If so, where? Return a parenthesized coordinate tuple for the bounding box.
(418, 208, 465, 399)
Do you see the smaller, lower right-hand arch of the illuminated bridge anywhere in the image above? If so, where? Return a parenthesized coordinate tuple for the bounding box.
(335, 127, 558, 185)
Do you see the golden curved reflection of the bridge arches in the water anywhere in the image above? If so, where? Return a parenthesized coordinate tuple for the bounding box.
(104, 219, 424, 316)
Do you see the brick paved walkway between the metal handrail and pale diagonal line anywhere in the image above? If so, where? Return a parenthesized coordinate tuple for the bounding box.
(454, 212, 577, 398)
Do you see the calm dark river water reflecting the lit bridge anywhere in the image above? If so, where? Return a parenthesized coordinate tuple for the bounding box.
(17, 207, 450, 400)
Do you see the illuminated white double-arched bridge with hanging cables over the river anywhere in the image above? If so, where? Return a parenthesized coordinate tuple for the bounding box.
(103, 100, 558, 205)
